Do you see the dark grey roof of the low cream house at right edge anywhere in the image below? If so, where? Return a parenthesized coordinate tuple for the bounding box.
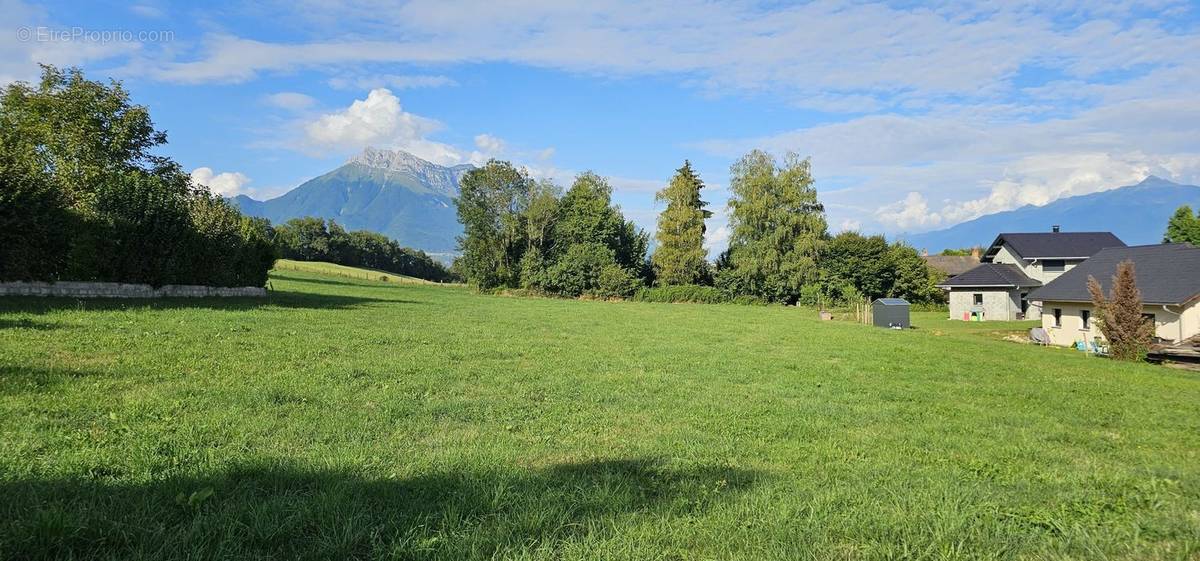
(1028, 243, 1200, 304)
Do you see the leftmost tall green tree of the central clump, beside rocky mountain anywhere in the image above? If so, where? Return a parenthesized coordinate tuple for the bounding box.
(455, 159, 534, 289)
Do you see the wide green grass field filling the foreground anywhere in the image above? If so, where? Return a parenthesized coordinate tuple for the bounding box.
(0, 266, 1200, 560)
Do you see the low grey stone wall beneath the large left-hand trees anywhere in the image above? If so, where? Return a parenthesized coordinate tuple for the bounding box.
(0, 282, 266, 298)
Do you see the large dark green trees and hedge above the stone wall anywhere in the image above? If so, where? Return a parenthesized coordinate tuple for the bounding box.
(0, 66, 275, 286)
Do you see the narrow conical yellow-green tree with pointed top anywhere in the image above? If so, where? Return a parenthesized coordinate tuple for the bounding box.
(652, 161, 713, 285)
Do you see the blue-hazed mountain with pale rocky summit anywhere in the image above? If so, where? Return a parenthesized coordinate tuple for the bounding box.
(232, 147, 474, 253)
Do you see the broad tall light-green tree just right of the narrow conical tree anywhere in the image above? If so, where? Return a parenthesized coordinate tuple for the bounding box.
(718, 150, 828, 303)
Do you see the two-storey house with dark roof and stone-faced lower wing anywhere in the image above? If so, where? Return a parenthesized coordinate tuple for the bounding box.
(938, 227, 1124, 321)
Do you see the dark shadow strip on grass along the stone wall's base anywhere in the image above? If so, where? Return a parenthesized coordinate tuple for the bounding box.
(0, 290, 424, 316)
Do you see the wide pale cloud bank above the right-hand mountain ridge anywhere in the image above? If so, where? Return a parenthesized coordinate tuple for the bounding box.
(701, 90, 1200, 233)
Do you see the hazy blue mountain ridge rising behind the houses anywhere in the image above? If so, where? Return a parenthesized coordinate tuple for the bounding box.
(898, 175, 1200, 253)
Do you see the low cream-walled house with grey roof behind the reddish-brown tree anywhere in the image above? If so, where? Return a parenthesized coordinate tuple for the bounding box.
(1028, 243, 1200, 345)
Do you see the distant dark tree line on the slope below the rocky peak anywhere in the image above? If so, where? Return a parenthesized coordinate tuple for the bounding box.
(272, 216, 456, 283)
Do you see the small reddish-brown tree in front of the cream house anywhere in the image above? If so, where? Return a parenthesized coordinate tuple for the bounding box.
(1087, 260, 1154, 361)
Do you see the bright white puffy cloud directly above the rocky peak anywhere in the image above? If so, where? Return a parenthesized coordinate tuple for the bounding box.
(304, 88, 466, 164)
